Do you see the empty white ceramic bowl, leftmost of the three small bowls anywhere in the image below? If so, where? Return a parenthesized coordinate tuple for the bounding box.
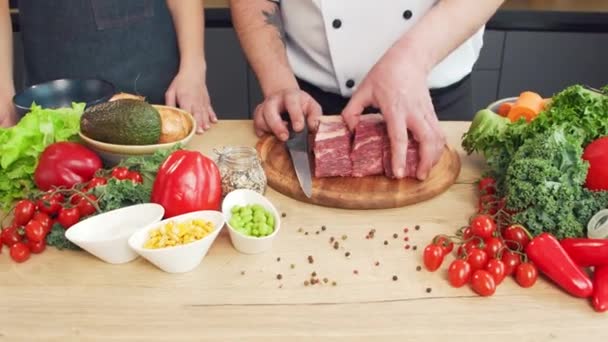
(65, 203, 165, 264)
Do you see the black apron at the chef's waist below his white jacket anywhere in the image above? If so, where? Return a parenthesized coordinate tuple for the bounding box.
(298, 75, 475, 121)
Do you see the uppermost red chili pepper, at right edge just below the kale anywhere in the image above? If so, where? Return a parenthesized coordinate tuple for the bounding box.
(560, 238, 608, 267)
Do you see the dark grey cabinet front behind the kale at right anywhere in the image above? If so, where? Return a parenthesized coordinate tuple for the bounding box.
(498, 32, 608, 98)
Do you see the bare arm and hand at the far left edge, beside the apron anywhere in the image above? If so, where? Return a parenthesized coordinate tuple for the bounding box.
(0, 0, 15, 127)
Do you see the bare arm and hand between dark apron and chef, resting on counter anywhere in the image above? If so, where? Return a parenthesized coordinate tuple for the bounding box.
(165, 0, 217, 133)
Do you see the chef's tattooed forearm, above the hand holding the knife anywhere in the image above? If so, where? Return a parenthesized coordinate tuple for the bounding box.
(230, 0, 298, 96)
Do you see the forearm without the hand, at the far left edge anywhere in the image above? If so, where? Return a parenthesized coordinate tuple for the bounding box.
(0, 0, 15, 97)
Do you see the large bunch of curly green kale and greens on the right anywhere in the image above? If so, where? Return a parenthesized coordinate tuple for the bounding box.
(462, 85, 608, 238)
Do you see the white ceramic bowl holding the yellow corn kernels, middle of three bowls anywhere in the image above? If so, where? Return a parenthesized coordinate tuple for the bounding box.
(129, 210, 224, 273)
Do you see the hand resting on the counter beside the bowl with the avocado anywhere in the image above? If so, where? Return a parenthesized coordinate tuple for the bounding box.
(165, 66, 217, 134)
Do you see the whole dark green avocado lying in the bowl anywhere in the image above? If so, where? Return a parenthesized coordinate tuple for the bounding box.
(80, 99, 162, 145)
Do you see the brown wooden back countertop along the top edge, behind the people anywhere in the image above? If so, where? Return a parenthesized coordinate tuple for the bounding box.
(205, 0, 608, 12)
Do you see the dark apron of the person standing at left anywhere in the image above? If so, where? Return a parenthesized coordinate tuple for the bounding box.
(19, 0, 179, 104)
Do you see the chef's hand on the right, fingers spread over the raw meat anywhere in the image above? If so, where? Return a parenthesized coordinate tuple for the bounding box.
(342, 49, 445, 180)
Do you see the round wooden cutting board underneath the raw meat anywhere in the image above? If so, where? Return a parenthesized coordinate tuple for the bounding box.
(256, 135, 460, 209)
